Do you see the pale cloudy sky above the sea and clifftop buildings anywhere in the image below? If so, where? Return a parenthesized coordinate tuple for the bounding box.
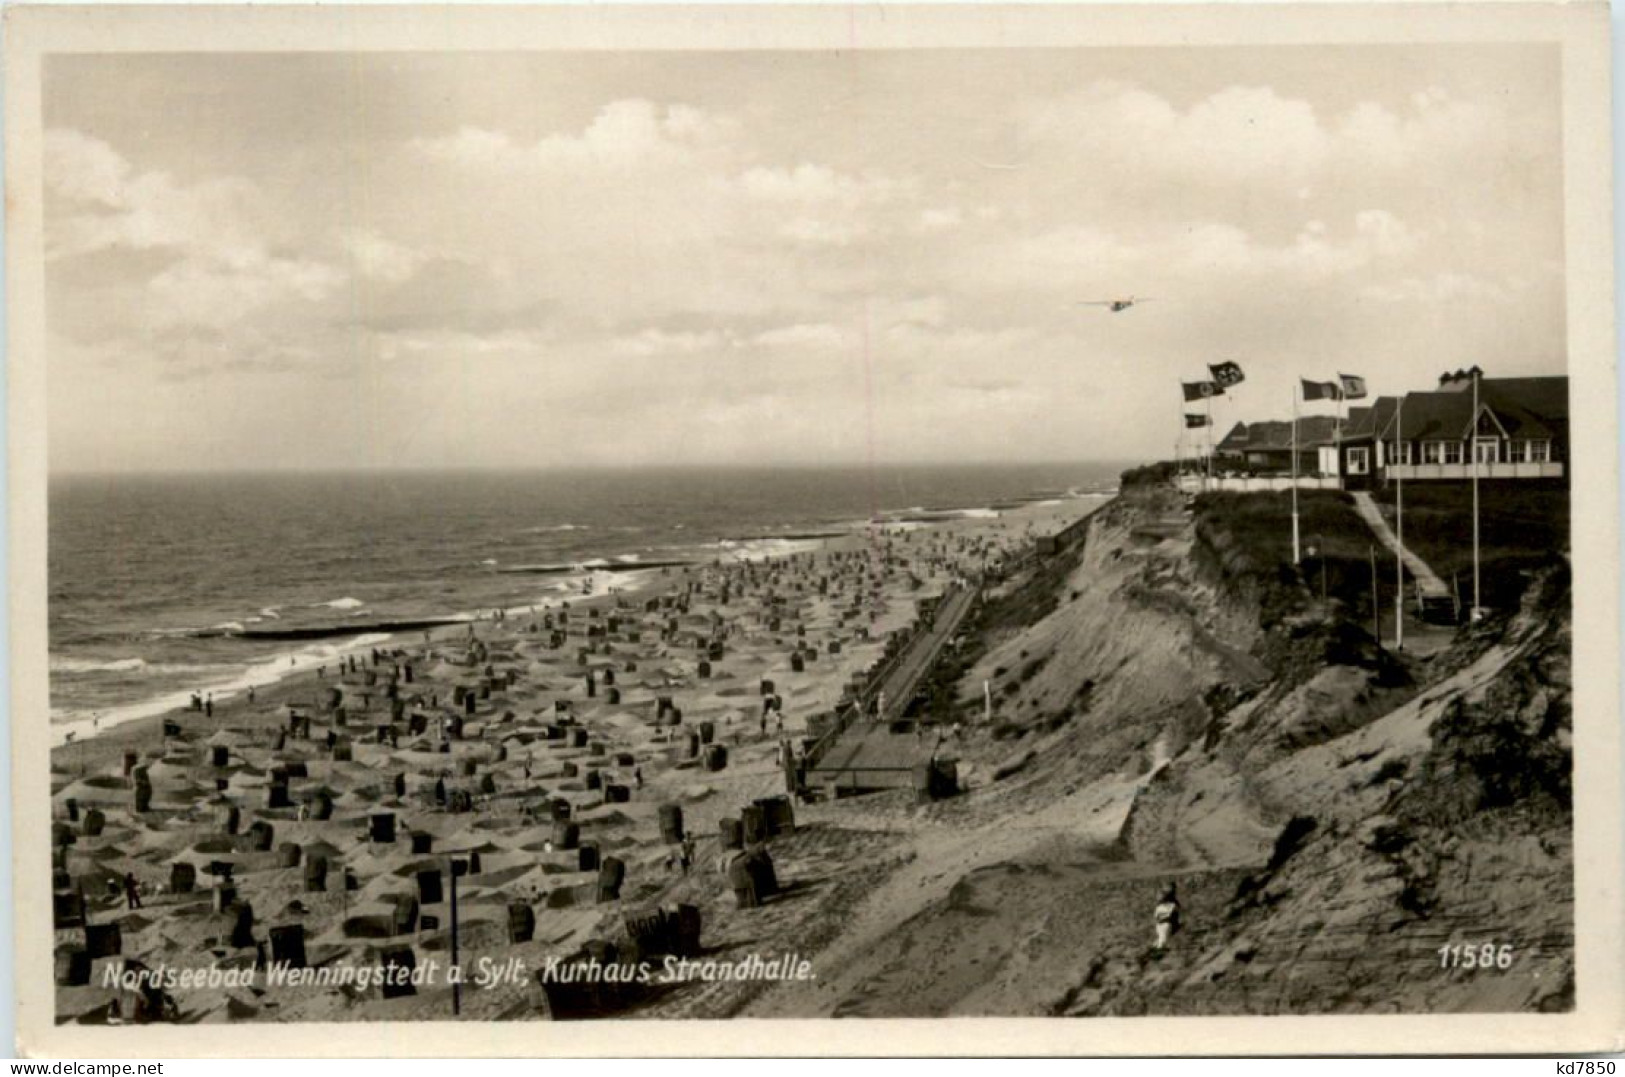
(44, 45, 1565, 471)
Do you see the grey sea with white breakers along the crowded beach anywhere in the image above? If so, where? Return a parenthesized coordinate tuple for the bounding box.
(49, 463, 1123, 741)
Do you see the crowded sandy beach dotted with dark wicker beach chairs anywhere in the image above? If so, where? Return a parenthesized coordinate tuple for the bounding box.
(52, 499, 1100, 1023)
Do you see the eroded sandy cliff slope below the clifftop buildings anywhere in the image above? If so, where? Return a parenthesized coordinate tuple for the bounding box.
(762, 487, 1573, 1015)
